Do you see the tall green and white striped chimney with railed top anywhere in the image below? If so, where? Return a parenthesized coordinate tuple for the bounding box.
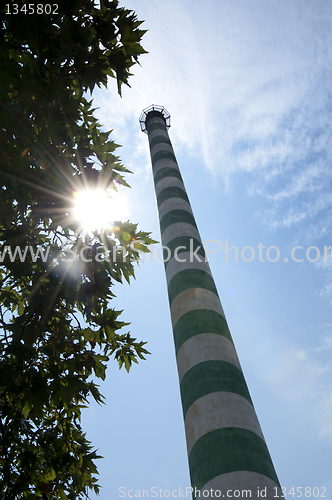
(140, 105, 282, 500)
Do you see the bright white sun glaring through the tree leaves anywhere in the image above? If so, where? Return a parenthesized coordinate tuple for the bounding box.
(74, 189, 129, 231)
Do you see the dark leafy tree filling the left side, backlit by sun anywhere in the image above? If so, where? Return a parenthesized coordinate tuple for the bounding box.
(0, 0, 153, 499)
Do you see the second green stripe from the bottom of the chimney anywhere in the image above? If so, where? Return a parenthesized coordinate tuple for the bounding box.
(180, 360, 252, 417)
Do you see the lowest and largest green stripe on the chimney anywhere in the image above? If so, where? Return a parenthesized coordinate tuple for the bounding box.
(189, 427, 279, 489)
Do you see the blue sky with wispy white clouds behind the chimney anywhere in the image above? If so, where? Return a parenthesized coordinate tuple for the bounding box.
(83, 0, 332, 500)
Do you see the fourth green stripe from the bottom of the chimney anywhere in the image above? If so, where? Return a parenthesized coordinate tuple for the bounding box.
(168, 269, 218, 305)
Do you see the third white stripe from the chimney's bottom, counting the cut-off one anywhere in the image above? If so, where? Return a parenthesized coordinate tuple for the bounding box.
(176, 333, 242, 383)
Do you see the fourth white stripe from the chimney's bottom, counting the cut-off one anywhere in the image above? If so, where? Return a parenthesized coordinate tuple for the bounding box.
(171, 288, 225, 328)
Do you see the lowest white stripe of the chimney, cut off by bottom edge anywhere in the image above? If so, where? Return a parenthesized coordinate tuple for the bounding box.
(201, 471, 283, 500)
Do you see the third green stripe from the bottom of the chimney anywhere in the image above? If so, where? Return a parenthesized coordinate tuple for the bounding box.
(173, 309, 233, 353)
